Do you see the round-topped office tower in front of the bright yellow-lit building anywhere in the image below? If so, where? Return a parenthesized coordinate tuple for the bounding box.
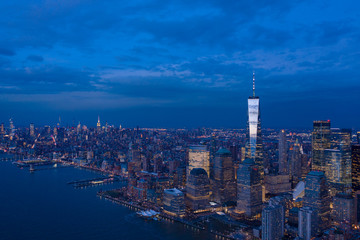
(186, 168, 210, 211)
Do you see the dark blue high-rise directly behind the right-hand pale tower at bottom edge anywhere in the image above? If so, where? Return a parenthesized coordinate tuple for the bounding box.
(304, 171, 330, 233)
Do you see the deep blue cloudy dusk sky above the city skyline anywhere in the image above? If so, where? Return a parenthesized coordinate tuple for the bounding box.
(0, 0, 360, 128)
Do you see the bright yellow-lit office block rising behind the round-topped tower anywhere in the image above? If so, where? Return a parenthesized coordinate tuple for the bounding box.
(186, 145, 210, 177)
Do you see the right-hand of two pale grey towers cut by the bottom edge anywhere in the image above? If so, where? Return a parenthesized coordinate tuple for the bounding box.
(298, 207, 317, 240)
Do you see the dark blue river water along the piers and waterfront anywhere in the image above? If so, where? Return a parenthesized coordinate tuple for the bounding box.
(0, 162, 209, 240)
